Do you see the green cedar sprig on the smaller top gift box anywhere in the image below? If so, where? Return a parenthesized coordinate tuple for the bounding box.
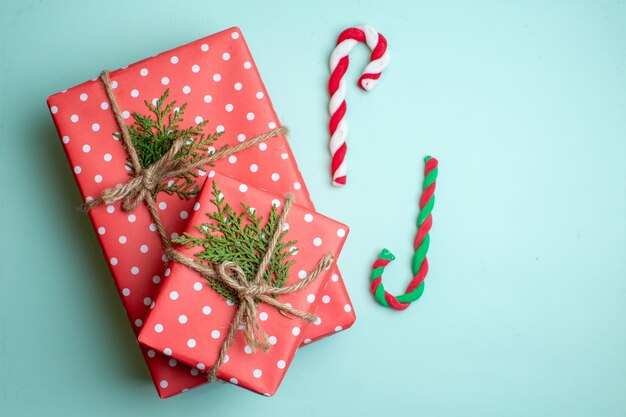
(174, 181, 297, 302)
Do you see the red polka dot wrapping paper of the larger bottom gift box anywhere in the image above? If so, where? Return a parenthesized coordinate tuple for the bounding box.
(48, 28, 355, 397)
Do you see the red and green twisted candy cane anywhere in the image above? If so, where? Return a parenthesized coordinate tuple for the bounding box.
(370, 156, 439, 310)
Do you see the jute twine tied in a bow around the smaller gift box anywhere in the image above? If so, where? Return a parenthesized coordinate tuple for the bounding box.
(166, 194, 334, 382)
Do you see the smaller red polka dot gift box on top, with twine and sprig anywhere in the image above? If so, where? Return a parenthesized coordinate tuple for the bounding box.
(139, 174, 348, 395)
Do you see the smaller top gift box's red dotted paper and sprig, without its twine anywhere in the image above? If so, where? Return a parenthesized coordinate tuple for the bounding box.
(139, 173, 348, 395)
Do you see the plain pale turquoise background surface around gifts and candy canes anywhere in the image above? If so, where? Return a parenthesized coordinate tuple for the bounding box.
(0, 0, 626, 417)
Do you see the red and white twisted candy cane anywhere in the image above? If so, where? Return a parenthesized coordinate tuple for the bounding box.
(328, 25, 389, 186)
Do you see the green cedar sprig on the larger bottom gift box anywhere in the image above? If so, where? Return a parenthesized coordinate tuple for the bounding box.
(115, 89, 225, 199)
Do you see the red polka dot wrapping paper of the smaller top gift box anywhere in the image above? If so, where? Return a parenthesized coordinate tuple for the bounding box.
(139, 173, 348, 396)
